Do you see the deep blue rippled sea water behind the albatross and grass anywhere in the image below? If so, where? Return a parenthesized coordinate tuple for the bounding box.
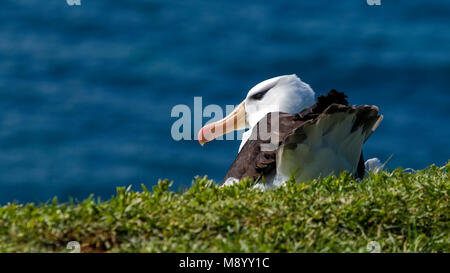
(0, 0, 450, 204)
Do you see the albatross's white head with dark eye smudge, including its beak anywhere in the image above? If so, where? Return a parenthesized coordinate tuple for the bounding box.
(198, 74, 315, 145)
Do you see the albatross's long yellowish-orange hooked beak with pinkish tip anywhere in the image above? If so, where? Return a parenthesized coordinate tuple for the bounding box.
(198, 100, 246, 146)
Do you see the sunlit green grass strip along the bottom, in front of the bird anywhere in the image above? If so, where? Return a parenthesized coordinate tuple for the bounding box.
(0, 162, 450, 252)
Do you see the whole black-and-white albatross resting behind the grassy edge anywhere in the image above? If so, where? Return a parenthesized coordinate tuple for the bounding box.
(198, 74, 383, 189)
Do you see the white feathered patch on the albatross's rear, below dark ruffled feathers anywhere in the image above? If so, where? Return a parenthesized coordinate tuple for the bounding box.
(274, 113, 365, 186)
